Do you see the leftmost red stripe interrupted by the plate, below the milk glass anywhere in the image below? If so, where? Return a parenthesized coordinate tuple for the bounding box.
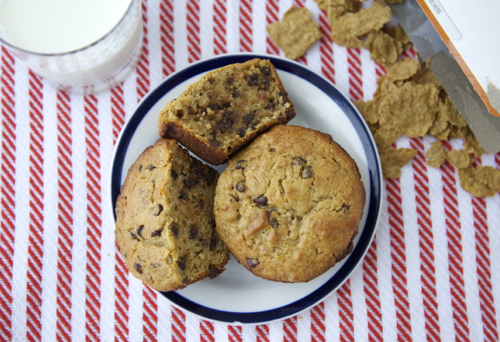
(111, 84, 129, 342)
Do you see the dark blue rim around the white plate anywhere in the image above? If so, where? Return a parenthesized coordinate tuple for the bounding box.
(111, 54, 382, 324)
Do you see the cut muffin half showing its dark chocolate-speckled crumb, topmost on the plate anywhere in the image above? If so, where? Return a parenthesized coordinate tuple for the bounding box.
(158, 59, 295, 165)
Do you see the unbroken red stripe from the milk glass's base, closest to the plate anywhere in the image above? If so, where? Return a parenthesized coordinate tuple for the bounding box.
(84, 95, 102, 341)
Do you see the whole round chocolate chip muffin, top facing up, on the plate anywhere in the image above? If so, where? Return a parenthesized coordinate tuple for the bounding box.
(214, 125, 365, 282)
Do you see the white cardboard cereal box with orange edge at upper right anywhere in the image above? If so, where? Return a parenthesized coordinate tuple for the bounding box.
(417, 0, 500, 117)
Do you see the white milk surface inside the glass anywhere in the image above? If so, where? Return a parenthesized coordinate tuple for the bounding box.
(0, 0, 131, 54)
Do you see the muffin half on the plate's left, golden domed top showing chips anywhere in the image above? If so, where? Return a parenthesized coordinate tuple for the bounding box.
(115, 139, 229, 291)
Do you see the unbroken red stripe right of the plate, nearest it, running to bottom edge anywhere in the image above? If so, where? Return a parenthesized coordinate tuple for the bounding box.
(386, 179, 411, 341)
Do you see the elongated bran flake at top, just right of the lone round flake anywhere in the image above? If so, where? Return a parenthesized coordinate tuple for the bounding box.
(330, 2, 392, 48)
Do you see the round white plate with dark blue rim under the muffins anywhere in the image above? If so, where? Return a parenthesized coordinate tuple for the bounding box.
(110, 54, 382, 324)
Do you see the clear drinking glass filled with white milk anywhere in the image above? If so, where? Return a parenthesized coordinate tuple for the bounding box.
(0, 0, 142, 94)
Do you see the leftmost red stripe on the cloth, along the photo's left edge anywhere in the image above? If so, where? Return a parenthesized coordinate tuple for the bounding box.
(0, 46, 17, 341)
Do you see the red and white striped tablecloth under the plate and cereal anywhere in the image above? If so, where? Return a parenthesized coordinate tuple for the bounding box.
(0, 0, 500, 341)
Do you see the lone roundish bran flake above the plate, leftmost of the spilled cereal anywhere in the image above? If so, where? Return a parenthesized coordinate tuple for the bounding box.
(267, 6, 323, 59)
